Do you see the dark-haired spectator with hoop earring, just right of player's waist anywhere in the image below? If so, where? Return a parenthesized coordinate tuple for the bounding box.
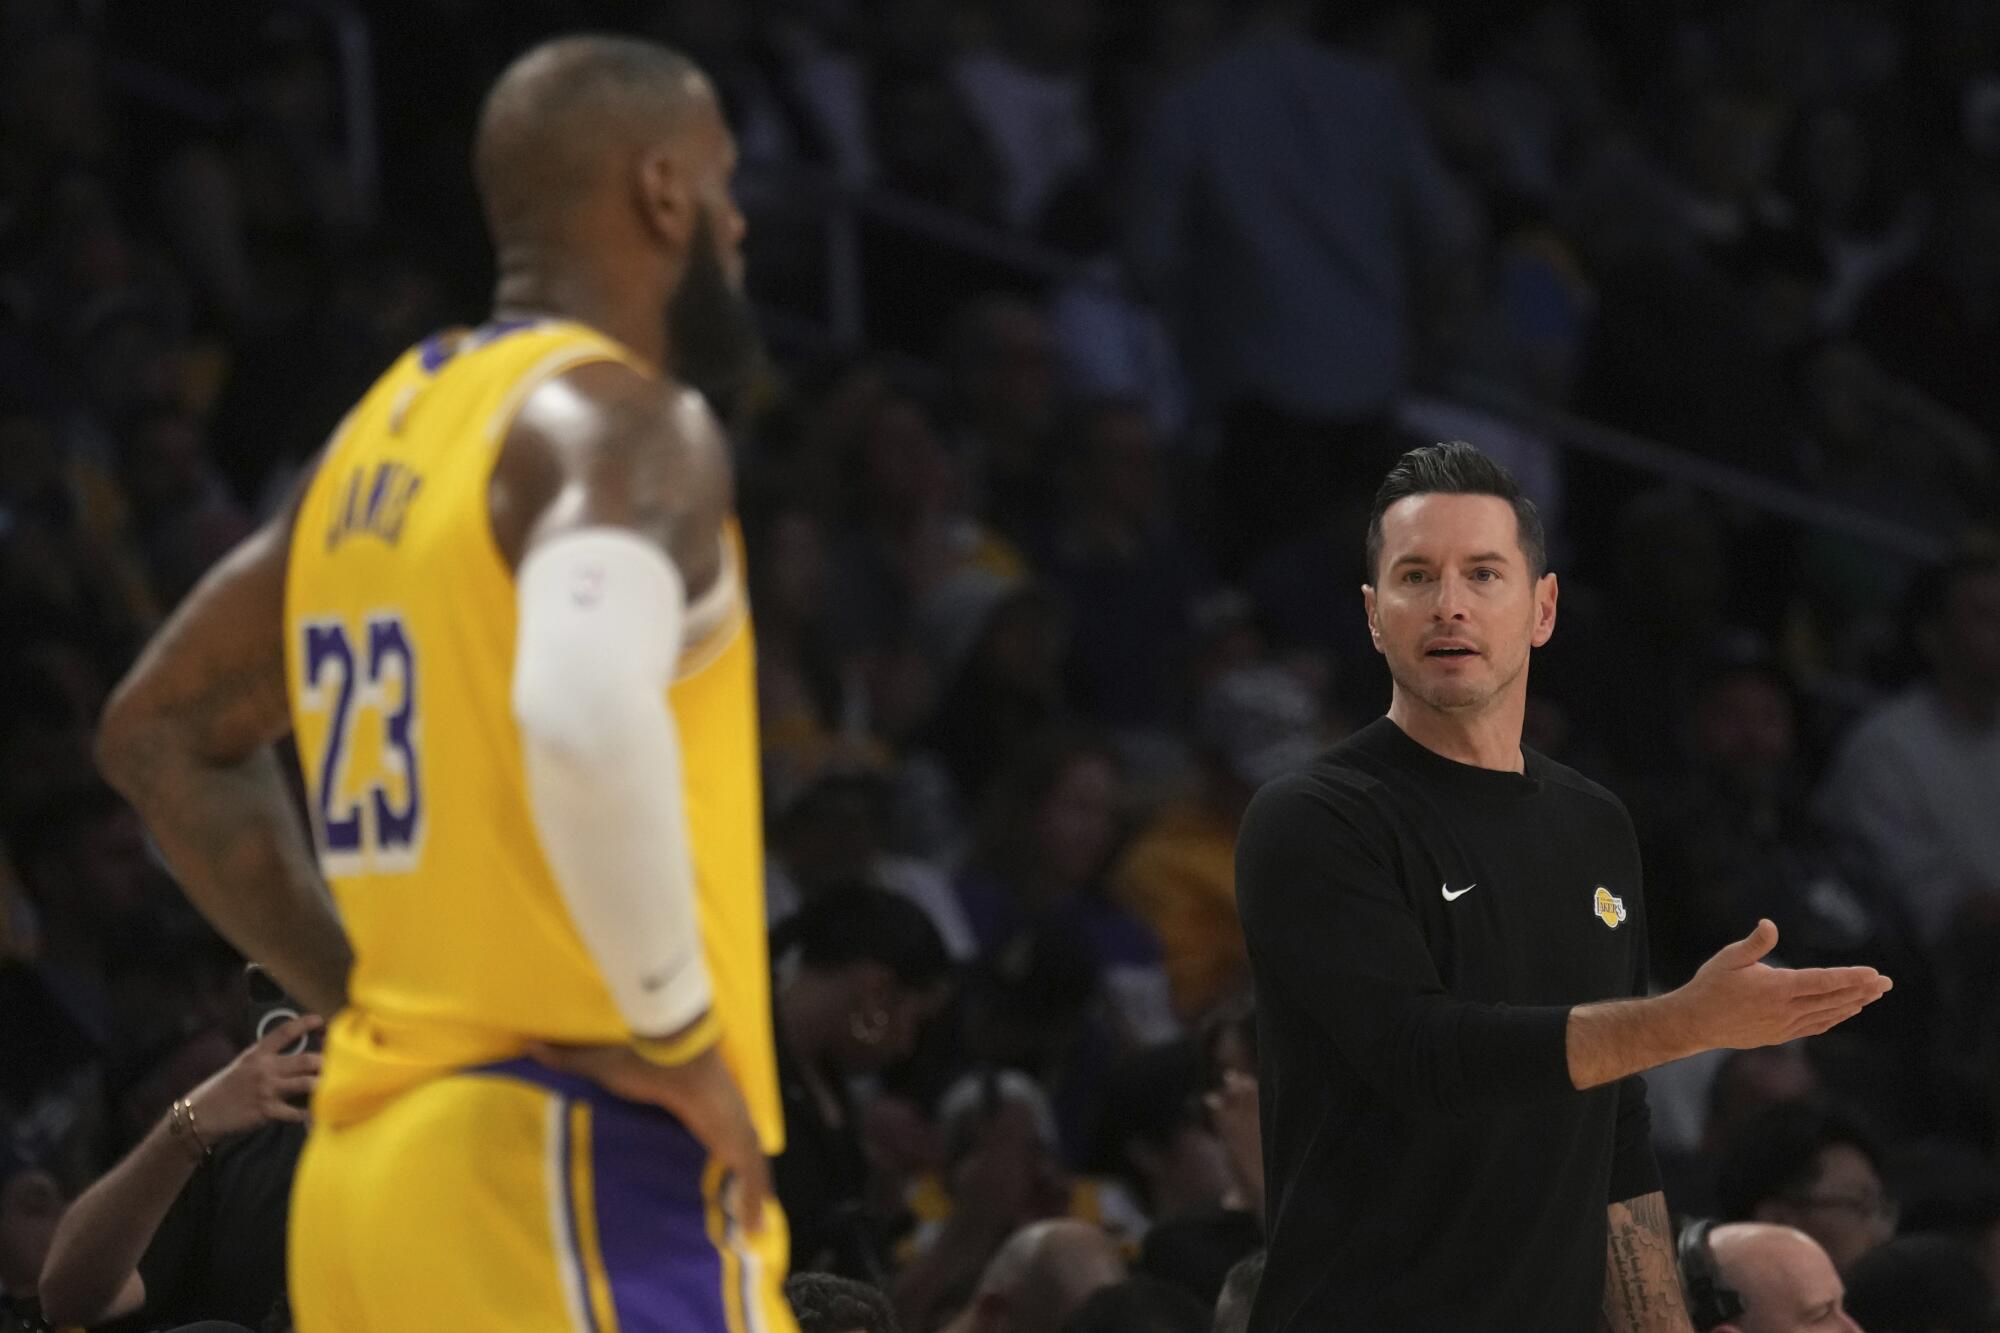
(772, 887, 950, 1275)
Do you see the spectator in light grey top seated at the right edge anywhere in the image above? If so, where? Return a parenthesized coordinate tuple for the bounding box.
(1820, 546, 2000, 943)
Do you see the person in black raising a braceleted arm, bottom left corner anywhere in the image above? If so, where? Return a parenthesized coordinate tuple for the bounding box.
(42, 1017, 320, 1327)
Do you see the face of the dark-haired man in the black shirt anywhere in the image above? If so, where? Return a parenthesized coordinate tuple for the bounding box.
(1362, 494, 1556, 711)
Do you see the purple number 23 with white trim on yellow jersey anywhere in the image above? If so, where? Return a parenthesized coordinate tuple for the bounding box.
(294, 610, 424, 875)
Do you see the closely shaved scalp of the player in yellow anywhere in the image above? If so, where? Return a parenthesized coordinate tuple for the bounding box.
(472, 36, 722, 248)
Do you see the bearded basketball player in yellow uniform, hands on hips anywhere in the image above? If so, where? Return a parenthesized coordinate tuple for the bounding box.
(100, 38, 794, 1333)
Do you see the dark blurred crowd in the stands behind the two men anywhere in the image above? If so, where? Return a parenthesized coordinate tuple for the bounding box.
(0, 0, 2000, 1333)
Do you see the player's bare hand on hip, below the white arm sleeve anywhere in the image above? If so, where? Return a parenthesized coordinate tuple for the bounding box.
(528, 1045, 770, 1235)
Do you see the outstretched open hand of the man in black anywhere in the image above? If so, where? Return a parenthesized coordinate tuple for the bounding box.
(1682, 921, 1892, 1051)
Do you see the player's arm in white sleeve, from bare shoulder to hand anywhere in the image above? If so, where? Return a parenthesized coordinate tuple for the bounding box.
(490, 364, 770, 1229)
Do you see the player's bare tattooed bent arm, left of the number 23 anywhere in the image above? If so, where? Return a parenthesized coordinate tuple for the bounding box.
(96, 466, 354, 1015)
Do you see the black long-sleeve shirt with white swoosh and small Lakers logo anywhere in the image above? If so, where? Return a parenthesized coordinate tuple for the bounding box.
(1236, 719, 1660, 1333)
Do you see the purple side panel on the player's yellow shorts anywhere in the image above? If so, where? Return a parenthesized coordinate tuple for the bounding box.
(472, 1061, 728, 1333)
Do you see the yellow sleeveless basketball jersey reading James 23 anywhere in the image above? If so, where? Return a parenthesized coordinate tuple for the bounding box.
(286, 320, 782, 1153)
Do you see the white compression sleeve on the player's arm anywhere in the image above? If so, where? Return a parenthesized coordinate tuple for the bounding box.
(514, 528, 710, 1037)
